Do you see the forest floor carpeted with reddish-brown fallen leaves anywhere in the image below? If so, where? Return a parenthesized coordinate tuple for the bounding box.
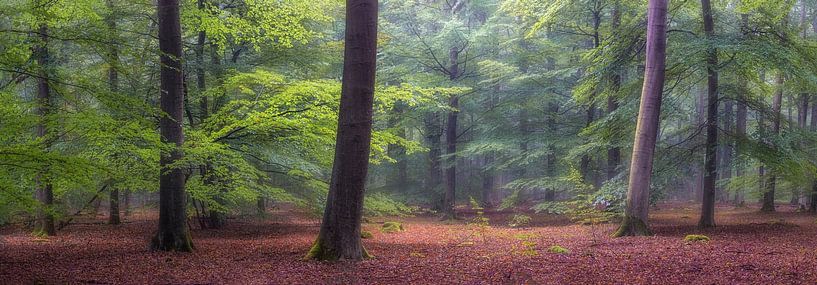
(0, 201, 817, 284)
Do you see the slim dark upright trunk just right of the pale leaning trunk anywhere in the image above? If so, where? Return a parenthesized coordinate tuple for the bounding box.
(698, 0, 718, 228)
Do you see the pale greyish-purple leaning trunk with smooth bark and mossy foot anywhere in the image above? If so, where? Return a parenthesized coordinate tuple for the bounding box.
(613, 0, 668, 237)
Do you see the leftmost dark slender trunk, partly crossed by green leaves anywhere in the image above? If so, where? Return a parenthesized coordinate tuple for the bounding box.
(34, 24, 57, 236)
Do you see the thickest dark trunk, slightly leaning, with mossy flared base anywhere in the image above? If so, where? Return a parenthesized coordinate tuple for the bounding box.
(306, 0, 378, 260)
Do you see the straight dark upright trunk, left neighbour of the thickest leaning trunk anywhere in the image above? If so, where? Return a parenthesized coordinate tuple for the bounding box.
(151, 0, 193, 251)
